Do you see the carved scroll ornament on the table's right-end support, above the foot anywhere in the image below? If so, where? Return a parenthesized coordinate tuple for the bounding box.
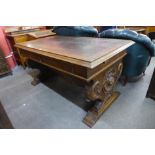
(87, 62, 123, 102)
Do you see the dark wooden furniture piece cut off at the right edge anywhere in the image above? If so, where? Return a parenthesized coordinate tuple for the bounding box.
(146, 69, 155, 100)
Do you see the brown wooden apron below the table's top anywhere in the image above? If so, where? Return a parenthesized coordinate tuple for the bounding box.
(18, 48, 126, 82)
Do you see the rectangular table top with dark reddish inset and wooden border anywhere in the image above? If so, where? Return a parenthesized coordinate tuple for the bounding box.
(16, 36, 134, 68)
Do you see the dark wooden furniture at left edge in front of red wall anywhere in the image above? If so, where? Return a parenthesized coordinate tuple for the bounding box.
(0, 49, 11, 76)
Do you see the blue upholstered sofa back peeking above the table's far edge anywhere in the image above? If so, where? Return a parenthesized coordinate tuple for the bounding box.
(53, 26, 98, 37)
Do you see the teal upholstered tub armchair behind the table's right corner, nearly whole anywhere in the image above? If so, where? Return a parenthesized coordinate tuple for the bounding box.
(99, 29, 155, 84)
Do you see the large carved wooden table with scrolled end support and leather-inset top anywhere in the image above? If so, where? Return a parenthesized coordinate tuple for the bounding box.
(16, 36, 134, 127)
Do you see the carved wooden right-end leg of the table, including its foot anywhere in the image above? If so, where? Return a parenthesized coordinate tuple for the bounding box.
(83, 62, 123, 127)
